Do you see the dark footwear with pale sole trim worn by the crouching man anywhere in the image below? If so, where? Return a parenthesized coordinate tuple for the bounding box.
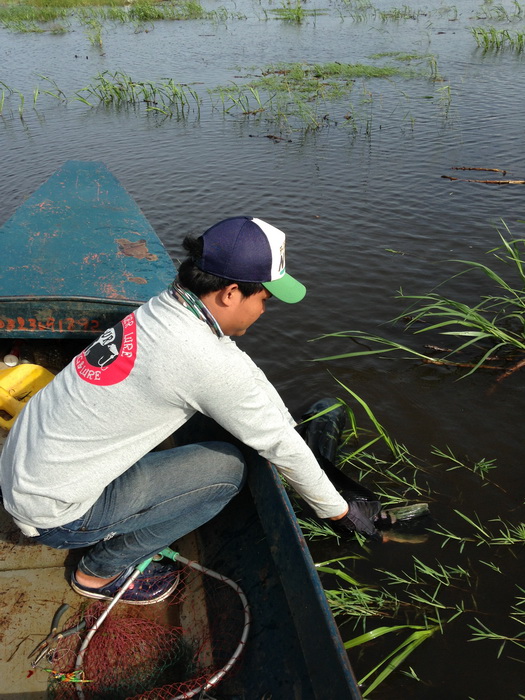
(71, 561, 180, 605)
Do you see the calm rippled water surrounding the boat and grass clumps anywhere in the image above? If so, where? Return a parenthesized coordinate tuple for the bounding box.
(0, 0, 525, 700)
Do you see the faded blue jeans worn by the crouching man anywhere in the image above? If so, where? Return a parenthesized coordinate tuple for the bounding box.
(35, 441, 245, 578)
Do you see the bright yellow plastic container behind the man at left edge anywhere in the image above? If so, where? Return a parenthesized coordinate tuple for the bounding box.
(0, 364, 55, 430)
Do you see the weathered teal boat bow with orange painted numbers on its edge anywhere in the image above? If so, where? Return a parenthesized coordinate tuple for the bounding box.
(0, 161, 175, 338)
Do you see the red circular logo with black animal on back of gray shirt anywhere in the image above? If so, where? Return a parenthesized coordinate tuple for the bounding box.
(75, 314, 137, 386)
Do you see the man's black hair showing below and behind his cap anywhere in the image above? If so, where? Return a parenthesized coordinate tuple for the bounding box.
(177, 236, 264, 297)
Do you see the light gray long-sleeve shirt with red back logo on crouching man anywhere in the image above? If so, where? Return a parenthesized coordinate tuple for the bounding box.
(0, 291, 346, 528)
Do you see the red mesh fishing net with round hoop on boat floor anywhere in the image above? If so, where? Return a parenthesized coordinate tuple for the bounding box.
(46, 564, 249, 700)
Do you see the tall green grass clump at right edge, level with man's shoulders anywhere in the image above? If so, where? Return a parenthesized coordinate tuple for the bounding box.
(315, 227, 525, 381)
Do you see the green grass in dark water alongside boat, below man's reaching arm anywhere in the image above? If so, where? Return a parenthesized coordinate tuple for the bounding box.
(296, 382, 525, 698)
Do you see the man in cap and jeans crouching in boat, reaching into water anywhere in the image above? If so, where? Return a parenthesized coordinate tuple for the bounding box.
(0, 217, 376, 605)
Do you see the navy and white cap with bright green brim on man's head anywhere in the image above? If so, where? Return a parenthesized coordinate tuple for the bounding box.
(197, 216, 306, 304)
